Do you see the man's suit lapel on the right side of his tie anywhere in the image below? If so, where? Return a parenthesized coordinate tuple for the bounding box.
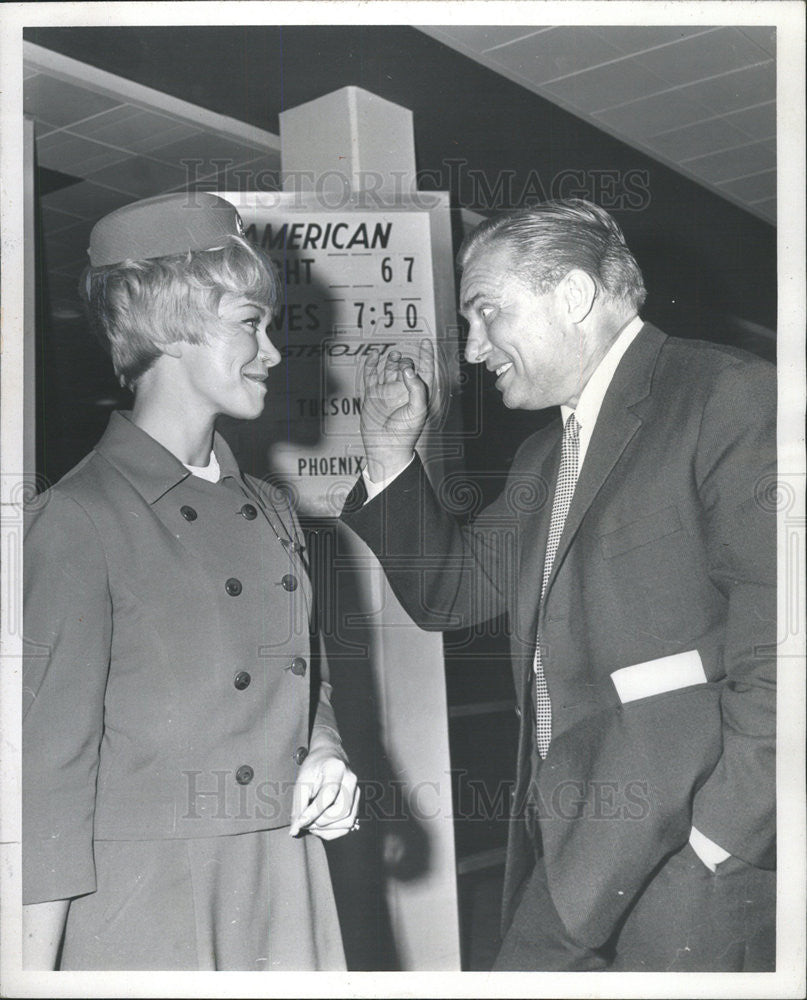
(544, 323, 666, 600)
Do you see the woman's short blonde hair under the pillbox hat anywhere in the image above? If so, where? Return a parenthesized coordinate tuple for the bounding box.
(80, 236, 280, 389)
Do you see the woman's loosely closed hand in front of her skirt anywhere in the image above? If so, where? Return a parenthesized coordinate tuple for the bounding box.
(289, 748, 361, 840)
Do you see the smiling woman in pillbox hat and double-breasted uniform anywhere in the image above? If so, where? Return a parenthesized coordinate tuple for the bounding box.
(23, 193, 358, 970)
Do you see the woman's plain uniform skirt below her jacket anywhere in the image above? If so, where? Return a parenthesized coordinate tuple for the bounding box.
(60, 827, 345, 971)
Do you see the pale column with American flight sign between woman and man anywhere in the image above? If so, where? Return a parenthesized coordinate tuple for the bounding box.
(243, 87, 460, 970)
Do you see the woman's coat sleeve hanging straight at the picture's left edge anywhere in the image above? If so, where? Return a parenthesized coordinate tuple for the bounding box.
(22, 491, 112, 903)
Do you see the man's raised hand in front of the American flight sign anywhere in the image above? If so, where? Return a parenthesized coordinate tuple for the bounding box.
(360, 339, 435, 482)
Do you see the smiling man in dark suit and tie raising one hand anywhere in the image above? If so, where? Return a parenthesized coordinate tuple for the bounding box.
(343, 200, 776, 971)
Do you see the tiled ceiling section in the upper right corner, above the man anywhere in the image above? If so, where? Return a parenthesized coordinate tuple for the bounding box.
(420, 25, 776, 223)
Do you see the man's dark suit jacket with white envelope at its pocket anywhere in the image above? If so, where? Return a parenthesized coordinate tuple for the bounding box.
(342, 324, 776, 947)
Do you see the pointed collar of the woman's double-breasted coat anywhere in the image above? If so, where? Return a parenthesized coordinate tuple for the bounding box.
(95, 410, 241, 503)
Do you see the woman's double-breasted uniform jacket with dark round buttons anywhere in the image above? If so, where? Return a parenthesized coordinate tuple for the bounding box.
(23, 413, 341, 967)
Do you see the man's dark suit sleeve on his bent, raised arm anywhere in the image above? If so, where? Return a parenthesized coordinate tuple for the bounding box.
(342, 456, 533, 631)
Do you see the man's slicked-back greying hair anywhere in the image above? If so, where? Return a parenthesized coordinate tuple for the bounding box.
(464, 198, 647, 309)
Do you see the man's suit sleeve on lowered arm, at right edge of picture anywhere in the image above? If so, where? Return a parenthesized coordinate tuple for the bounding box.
(692, 363, 776, 867)
